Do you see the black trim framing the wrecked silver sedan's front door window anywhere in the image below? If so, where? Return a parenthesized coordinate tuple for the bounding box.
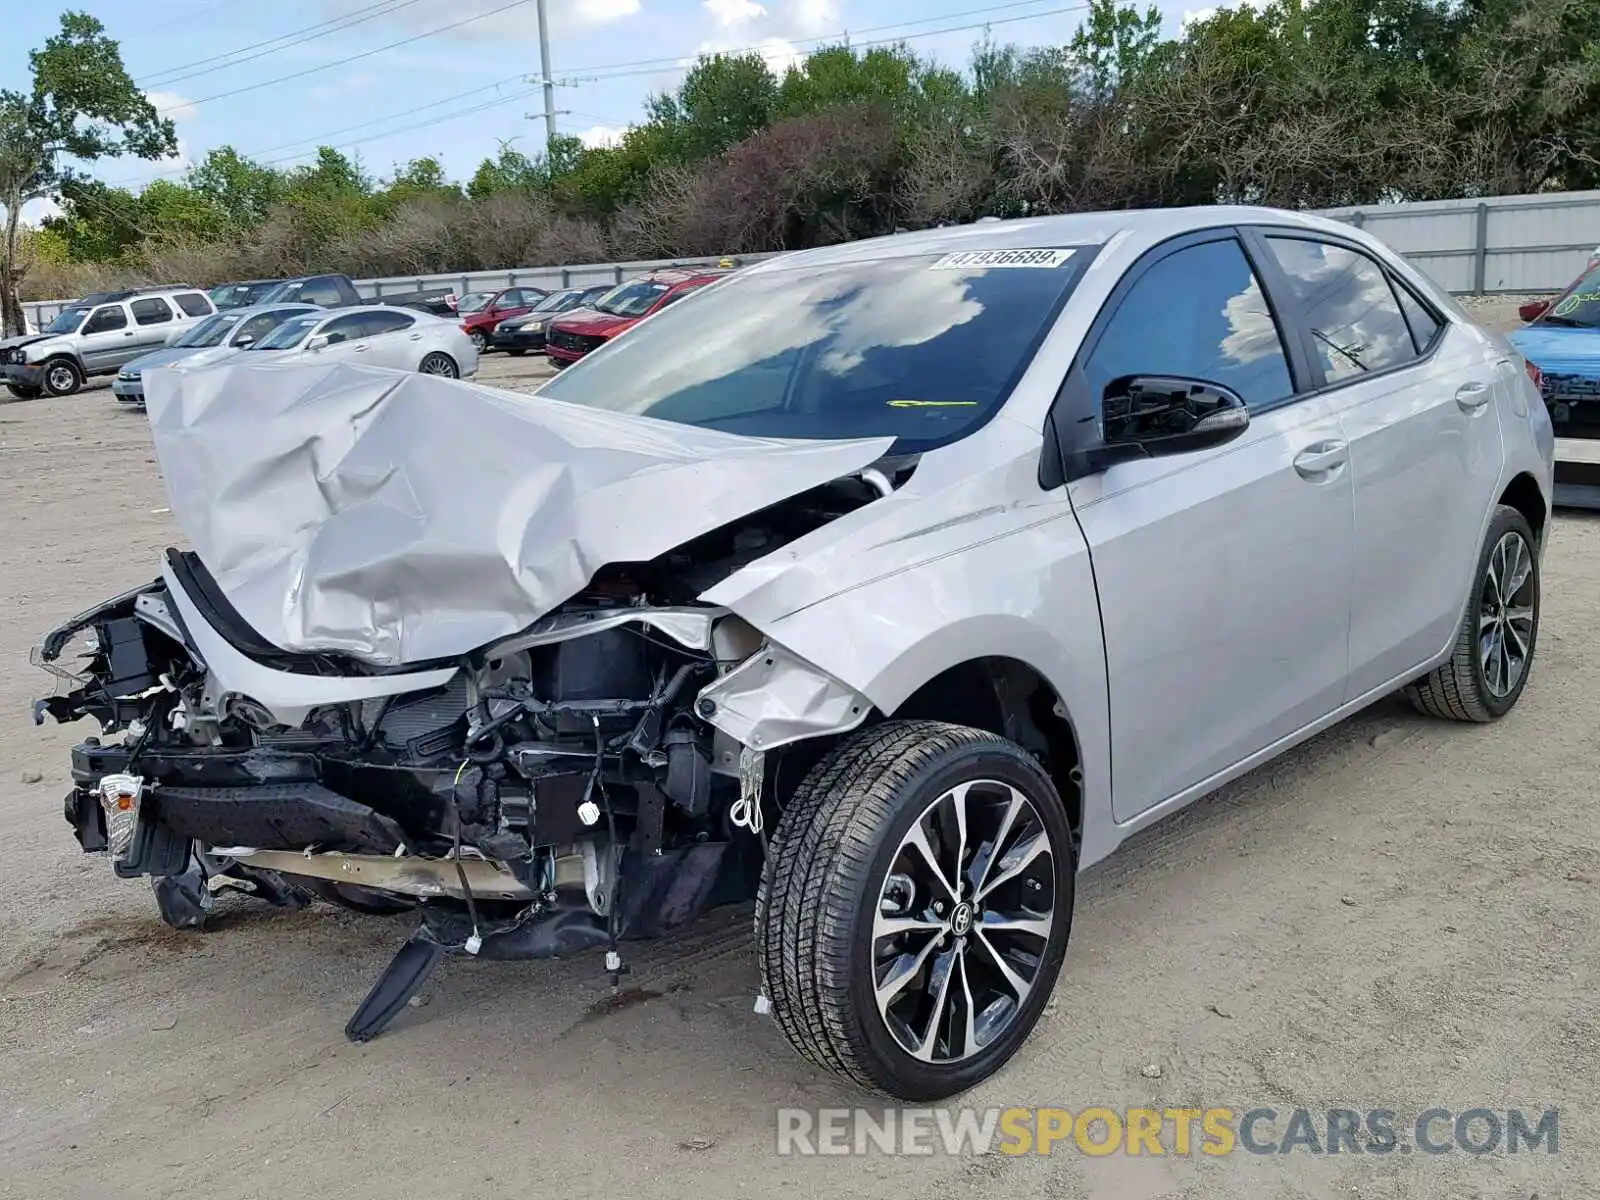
(1038, 224, 1320, 491)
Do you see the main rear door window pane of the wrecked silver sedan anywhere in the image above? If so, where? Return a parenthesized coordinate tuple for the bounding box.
(1267, 237, 1416, 384)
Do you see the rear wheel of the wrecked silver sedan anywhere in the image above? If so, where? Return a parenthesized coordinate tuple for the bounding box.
(1405, 504, 1539, 723)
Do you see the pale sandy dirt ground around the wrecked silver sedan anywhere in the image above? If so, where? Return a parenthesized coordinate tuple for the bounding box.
(0, 312, 1600, 1200)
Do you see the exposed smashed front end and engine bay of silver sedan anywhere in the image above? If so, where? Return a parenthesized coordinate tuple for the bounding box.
(35, 473, 912, 1040)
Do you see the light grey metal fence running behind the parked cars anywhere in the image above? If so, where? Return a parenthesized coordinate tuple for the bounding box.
(22, 192, 1600, 326)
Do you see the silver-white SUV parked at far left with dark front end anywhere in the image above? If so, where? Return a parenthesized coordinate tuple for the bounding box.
(0, 288, 216, 400)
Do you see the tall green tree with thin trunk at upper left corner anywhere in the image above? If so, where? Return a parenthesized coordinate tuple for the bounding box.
(0, 13, 178, 334)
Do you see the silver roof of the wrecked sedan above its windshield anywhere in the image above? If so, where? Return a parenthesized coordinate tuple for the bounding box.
(736, 205, 1352, 274)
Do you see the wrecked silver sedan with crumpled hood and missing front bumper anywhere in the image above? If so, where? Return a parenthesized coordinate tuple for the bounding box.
(28, 208, 1552, 1101)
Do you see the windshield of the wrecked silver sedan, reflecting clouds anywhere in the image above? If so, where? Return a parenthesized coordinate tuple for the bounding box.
(539, 248, 1093, 453)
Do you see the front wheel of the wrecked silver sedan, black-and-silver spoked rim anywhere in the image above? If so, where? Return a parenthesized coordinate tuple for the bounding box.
(755, 722, 1077, 1101)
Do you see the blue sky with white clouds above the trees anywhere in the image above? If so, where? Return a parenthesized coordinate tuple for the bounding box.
(0, 0, 1197, 218)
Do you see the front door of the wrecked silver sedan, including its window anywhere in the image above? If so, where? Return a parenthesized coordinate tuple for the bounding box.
(1069, 230, 1354, 821)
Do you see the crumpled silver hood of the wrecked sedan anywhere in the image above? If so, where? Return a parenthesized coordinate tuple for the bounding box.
(144, 362, 893, 666)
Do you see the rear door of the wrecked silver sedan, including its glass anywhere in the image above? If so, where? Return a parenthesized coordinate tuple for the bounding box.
(1259, 229, 1509, 699)
